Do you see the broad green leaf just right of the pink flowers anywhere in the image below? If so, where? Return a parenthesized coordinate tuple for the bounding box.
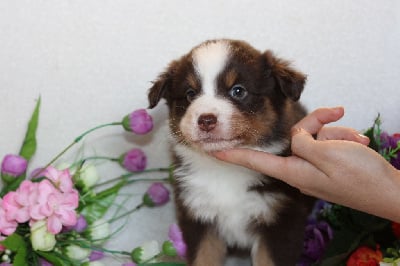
(80, 181, 126, 224)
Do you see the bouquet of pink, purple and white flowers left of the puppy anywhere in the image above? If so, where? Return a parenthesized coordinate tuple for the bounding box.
(0, 99, 186, 266)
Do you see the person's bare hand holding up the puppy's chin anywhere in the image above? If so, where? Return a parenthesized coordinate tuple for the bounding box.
(213, 107, 400, 222)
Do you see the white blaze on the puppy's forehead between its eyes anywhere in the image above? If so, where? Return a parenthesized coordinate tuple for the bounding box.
(192, 41, 229, 95)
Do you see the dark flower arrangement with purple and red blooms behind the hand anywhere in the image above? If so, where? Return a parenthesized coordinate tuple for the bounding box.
(298, 116, 400, 266)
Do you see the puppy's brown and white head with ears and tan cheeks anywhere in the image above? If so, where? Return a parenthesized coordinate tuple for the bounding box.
(149, 40, 306, 152)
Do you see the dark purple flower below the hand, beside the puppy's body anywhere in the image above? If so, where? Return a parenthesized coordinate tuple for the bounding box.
(299, 221, 333, 265)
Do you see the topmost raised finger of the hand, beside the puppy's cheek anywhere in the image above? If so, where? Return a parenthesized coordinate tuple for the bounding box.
(292, 107, 344, 134)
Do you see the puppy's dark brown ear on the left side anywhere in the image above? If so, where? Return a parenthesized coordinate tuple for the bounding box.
(148, 62, 176, 108)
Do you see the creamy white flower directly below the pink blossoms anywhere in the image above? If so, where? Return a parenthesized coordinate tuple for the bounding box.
(31, 220, 56, 251)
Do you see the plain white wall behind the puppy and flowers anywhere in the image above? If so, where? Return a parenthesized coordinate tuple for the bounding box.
(0, 0, 400, 263)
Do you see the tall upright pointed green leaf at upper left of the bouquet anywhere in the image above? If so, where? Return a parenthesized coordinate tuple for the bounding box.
(19, 97, 40, 161)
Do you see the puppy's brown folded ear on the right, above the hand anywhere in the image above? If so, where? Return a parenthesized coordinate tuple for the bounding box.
(263, 51, 307, 101)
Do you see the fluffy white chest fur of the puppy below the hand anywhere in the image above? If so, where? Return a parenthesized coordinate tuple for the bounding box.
(175, 144, 284, 248)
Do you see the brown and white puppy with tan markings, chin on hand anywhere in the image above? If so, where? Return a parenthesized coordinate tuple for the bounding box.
(149, 39, 312, 266)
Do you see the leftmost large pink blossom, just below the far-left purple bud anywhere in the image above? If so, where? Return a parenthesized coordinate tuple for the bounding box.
(3, 180, 38, 223)
